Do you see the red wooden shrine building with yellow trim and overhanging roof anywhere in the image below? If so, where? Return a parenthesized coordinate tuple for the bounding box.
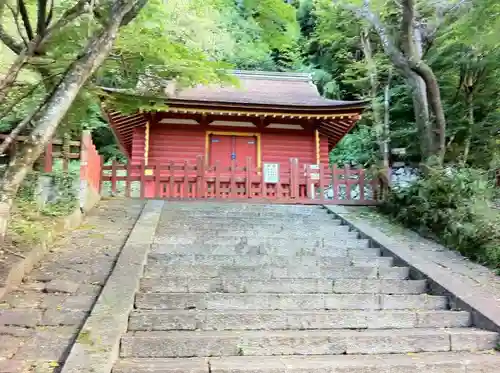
(102, 71, 366, 202)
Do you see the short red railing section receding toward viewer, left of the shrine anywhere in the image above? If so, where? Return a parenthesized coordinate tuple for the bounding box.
(80, 131, 103, 193)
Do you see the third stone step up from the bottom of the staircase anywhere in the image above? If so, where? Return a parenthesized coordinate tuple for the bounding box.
(129, 310, 470, 331)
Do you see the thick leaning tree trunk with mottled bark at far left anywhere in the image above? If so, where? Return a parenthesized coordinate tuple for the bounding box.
(0, 0, 136, 244)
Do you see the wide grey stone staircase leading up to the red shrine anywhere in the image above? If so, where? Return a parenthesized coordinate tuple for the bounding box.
(113, 203, 499, 373)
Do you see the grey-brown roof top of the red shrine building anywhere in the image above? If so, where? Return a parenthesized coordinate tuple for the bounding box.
(165, 71, 364, 108)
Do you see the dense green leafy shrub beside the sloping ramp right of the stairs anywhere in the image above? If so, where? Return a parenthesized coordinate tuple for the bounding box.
(380, 168, 500, 270)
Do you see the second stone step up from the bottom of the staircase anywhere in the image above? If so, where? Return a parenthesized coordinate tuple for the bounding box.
(120, 328, 498, 358)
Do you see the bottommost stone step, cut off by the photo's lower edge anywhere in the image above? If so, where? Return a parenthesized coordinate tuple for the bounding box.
(113, 352, 500, 373)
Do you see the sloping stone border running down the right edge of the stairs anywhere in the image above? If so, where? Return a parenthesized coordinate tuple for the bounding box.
(323, 205, 500, 333)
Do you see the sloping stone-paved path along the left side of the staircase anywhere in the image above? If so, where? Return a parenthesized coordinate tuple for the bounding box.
(0, 200, 143, 373)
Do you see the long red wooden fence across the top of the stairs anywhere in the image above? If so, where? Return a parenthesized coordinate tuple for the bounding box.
(101, 156, 382, 205)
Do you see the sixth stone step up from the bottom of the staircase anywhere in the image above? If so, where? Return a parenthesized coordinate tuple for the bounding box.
(145, 262, 409, 280)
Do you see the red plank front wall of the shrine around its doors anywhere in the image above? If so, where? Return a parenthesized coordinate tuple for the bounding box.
(132, 124, 328, 167)
